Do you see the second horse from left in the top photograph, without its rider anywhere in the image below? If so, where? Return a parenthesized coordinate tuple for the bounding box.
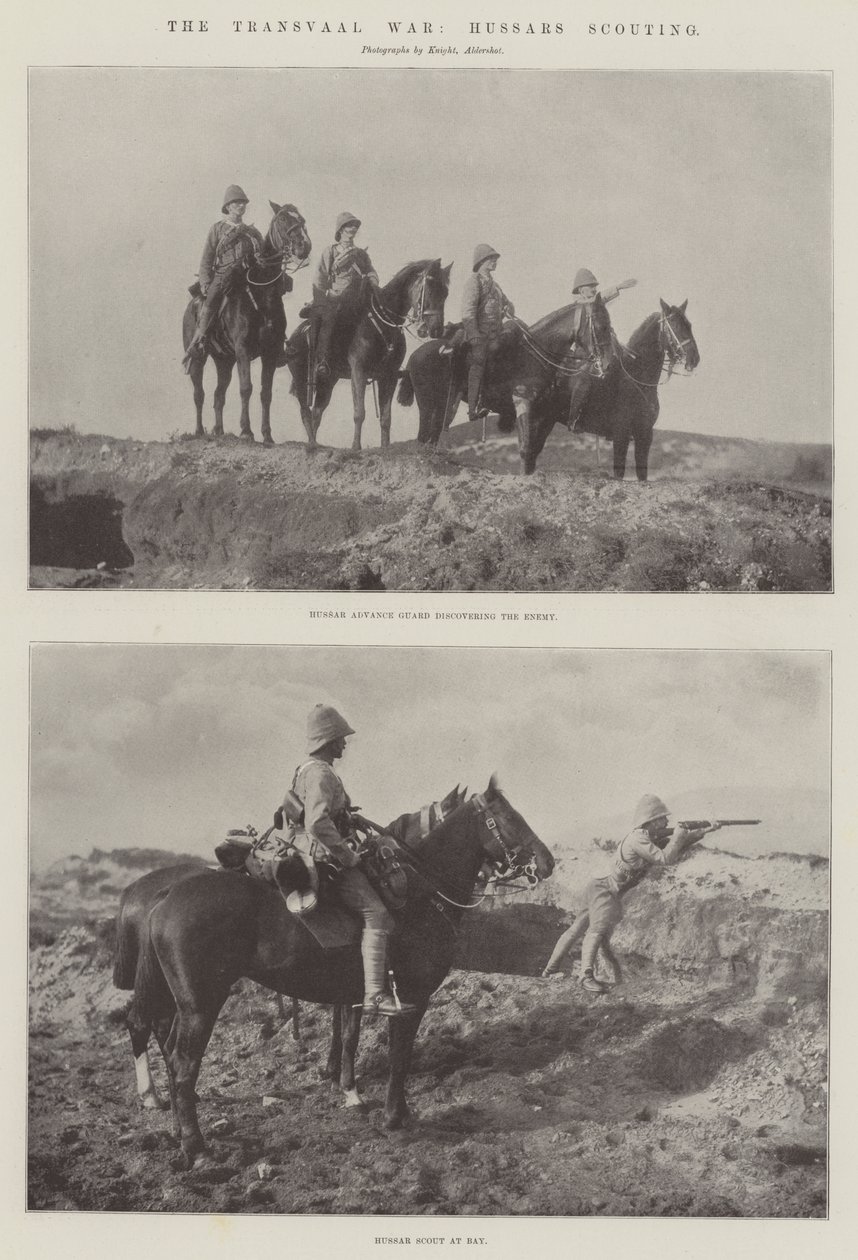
(287, 258, 452, 451)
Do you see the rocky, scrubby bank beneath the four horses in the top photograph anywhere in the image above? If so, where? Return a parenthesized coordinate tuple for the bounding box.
(30, 425, 830, 591)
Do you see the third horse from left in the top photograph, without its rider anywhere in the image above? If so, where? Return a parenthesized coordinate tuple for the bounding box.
(398, 302, 614, 473)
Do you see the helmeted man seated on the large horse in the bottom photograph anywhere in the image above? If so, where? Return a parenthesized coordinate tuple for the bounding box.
(285, 704, 415, 1017)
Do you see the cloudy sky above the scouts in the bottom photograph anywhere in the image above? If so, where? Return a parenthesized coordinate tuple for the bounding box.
(30, 644, 830, 869)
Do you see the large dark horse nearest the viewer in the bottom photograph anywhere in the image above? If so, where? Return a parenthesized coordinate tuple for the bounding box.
(135, 777, 554, 1167)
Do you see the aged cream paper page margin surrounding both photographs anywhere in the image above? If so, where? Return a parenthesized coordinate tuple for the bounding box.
(0, 0, 858, 1260)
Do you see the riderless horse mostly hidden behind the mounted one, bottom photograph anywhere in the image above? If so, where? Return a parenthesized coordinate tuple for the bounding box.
(113, 784, 465, 1110)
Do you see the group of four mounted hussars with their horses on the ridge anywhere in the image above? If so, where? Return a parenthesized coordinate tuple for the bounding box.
(178, 185, 699, 480)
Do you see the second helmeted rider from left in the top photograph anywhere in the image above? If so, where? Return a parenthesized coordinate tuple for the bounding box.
(310, 210, 378, 382)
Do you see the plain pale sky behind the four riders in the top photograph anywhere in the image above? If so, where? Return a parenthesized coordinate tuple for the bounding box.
(30, 67, 832, 445)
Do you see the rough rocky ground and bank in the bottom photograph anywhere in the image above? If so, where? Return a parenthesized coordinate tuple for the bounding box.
(29, 851, 828, 1217)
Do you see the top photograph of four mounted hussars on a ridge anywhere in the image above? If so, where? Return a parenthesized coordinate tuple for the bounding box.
(29, 67, 833, 595)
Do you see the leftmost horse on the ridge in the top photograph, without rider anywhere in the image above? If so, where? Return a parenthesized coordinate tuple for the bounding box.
(181, 202, 312, 446)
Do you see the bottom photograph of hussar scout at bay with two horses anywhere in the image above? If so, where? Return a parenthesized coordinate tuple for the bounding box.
(26, 644, 830, 1214)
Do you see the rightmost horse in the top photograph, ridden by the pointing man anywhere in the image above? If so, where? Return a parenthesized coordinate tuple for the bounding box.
(519, 300, 701, 481)
